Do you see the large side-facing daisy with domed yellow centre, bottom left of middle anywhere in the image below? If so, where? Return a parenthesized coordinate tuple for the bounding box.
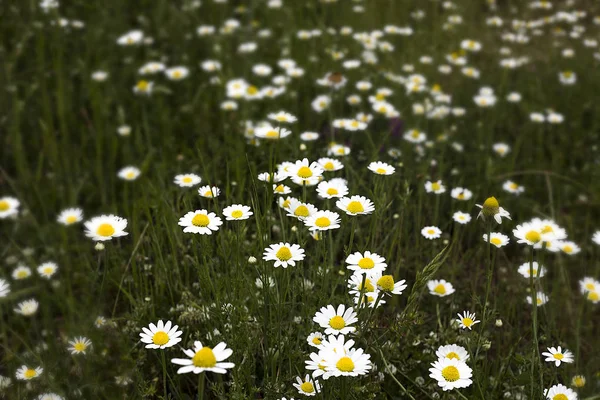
(171, 341, 235, 374)
